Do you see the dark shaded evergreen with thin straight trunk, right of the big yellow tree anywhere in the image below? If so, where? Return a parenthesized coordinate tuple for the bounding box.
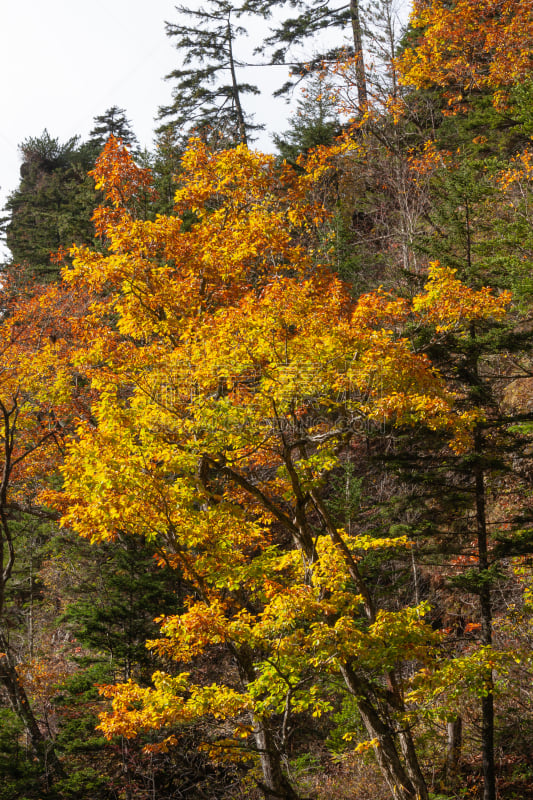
(388, 310, 533, 800)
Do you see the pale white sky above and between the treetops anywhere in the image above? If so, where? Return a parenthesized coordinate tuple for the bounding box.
(0, 0, 407, 247)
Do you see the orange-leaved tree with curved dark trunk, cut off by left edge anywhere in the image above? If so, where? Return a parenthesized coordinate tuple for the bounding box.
(0, 288, 84, 782)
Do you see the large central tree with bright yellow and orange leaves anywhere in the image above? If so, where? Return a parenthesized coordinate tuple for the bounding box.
(42, 131, 520, 799)
